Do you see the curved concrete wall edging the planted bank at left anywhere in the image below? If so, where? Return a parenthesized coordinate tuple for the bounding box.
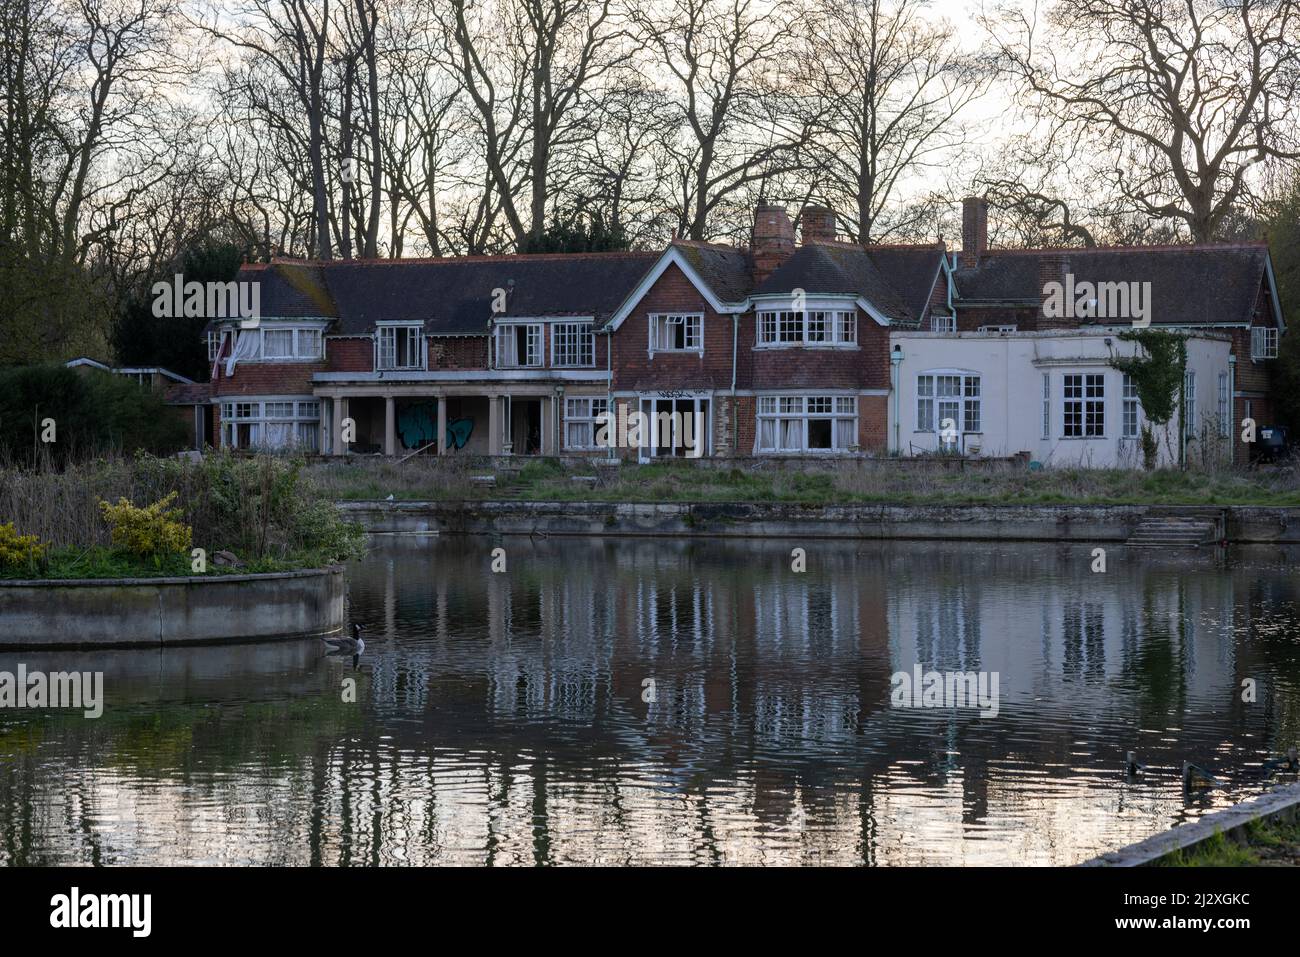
(0, 567, 345, 648)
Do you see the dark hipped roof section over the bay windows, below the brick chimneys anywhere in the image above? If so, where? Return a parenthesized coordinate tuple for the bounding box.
(753, 243, 944, 321)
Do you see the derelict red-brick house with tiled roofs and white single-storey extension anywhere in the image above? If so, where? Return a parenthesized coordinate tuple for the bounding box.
(200, 199, 1283, 464)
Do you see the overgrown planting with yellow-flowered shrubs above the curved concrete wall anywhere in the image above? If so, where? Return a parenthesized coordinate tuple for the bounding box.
(0, 454, 364, 580)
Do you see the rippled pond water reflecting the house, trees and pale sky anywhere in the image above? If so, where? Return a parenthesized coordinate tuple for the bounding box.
(0, 538, 1300, 865)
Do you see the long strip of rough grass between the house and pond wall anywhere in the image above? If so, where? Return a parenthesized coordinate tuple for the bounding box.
(307, 458, 1300, 506)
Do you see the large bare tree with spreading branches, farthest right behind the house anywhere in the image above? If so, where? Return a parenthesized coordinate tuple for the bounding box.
(985, 0, 1300, 242)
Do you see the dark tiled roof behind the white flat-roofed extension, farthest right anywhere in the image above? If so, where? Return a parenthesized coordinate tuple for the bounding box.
(954, 243, 1271, 325)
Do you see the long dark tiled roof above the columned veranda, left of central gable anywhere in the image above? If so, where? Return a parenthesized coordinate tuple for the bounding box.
(239, 252, 659, 335)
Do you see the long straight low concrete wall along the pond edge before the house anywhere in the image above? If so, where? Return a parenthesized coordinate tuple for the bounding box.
(341, 502, 1300, 545)
